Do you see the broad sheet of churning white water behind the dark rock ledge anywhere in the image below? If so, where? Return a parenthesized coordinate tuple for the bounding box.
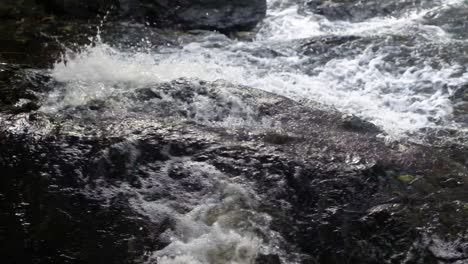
(44, 0, 468, 137)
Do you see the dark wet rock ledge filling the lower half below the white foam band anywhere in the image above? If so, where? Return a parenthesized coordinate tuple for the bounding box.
(0, 69, 468, 264)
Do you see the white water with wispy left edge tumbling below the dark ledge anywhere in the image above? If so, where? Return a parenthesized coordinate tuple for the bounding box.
(89, 155, 288, 264)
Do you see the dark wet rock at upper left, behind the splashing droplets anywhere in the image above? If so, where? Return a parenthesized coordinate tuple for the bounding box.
(0, 16, 187, 69)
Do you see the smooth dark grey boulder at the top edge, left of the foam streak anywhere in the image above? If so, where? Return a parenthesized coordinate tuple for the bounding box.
(42, 0, 266, 31)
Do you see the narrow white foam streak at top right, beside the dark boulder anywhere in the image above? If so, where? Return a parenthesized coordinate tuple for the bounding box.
(257, 0, 464, 41)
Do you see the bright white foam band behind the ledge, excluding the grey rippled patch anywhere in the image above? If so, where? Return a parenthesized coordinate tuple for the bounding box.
(46, 0, 468, 137)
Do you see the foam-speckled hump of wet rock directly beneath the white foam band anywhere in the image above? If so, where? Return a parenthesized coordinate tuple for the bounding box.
(44, 79, 267, 127)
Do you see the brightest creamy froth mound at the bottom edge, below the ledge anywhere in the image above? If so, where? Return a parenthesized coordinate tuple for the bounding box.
(150, 184, 268, 264)
